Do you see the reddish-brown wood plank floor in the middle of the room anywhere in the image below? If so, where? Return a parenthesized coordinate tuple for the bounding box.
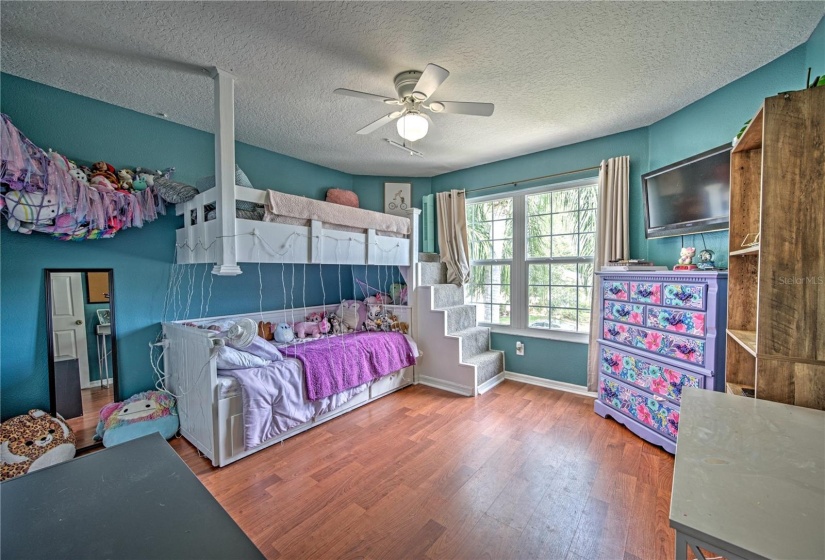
(171, 381, 674, 560)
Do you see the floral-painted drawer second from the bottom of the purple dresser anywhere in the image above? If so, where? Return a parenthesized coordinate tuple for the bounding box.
(600, 346, 705, 404)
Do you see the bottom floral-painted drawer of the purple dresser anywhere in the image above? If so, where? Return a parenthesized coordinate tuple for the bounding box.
(599, 375, 679, 441)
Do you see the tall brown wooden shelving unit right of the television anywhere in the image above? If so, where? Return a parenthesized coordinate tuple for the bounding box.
(725, 87, 825, 410)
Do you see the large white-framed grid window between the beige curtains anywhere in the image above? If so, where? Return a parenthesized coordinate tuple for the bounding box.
(466, 179, 598, 333)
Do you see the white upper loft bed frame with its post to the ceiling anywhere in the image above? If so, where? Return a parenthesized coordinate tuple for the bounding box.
(176, 68, 421, 278)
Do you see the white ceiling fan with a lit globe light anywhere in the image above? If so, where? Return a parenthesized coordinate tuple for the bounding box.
(334, 64, 495, 143)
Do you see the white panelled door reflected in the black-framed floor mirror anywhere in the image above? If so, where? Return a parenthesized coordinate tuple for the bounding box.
(51, 272, 89, 389)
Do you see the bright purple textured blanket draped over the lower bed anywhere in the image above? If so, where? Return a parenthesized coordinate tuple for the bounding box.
(281, 332, 415, 401)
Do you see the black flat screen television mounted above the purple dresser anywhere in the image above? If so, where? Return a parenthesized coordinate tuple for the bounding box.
(642, 144, 731, 239)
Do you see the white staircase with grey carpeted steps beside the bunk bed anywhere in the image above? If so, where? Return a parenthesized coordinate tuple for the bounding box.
(415, 253, 504, 396)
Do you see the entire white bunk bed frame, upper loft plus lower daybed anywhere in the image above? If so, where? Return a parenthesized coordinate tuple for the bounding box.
(163, 69, 421, 466)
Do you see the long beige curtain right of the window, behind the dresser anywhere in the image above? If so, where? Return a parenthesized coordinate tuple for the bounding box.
(587, 156, 630, 391)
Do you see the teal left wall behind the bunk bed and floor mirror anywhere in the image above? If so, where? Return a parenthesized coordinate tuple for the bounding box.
(0, 74, 352, 418)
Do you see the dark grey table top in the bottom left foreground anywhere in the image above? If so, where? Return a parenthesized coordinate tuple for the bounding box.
(0, 434, 263, 560)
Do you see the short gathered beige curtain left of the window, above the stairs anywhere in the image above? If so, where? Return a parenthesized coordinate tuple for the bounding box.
(436, 189, 470, 286)
